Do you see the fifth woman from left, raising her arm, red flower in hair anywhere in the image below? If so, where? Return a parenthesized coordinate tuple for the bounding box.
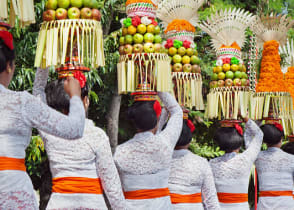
(210, 119, 263, 210)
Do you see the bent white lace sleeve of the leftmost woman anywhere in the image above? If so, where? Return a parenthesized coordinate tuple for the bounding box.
(21, 92, 85, 139)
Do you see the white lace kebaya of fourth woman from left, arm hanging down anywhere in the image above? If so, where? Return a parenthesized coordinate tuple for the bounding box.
(168, 149, 220, 210)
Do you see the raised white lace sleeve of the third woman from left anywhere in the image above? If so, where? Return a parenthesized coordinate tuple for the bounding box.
(158, 92, 183, 148)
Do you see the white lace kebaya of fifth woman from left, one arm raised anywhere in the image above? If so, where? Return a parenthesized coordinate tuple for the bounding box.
(210, 120, 263, 210)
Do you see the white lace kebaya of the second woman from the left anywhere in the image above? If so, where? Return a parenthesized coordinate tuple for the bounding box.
(34, 69, 126, 210)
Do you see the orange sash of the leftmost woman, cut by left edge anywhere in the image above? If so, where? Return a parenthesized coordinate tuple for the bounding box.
(0, 157, 26, 171)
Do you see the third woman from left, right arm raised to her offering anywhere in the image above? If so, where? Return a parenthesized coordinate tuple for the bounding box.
(114, 92, 183, 210)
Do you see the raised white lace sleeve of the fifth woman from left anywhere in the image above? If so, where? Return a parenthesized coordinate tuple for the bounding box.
(240, 120, 263, 163)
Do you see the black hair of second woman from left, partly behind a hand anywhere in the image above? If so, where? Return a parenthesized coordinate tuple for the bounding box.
(45, 79, 89, 112)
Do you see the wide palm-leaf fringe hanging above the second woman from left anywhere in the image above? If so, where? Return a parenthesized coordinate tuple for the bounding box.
(35, 19, 105, 68)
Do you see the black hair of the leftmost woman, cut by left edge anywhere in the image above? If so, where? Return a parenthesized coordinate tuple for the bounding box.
(0, 39, 15, 73)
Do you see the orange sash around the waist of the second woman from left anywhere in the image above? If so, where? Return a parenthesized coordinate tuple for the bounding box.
(52, 177, 103, 194)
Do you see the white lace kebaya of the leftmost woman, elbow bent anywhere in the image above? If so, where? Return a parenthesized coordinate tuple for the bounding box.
(0, 72, 85, 210)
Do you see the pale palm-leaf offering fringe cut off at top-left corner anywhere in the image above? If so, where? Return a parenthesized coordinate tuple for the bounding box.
(0, 0, 36, 27)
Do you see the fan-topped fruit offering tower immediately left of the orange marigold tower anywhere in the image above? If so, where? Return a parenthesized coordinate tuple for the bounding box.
(199, 8, 253, 120)
